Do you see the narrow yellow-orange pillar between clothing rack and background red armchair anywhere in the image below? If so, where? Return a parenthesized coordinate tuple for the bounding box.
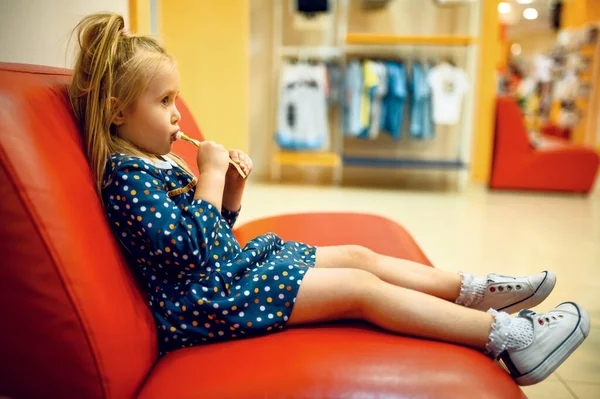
(471, 0, 501, 183)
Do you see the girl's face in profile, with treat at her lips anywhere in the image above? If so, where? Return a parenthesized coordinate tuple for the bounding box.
(114, 62, 181, 155)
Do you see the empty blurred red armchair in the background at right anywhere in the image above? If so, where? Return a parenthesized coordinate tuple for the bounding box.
(489, 97, 599, 193)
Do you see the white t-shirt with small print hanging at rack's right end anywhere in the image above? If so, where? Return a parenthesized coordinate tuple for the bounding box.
(427, 63, 469, 125)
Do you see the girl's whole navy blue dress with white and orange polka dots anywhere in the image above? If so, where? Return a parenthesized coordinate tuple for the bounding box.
(102, 154, 316, 355)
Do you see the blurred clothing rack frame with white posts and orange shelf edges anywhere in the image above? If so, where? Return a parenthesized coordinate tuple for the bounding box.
(271, 0, 481, 188)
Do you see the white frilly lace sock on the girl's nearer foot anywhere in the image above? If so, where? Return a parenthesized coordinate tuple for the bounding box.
(485, 309, 533, 358)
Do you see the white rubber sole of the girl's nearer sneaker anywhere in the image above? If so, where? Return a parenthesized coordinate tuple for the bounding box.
(500, 302, 590, 386)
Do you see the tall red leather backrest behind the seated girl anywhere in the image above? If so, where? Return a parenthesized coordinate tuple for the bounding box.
(0, 63, 201, 398)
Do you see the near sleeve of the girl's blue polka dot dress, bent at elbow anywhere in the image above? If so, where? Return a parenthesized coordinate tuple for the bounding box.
(103, 161, 222, 270)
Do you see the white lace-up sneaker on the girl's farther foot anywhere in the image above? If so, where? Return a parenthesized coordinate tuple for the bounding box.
(471, 271, 556, 314)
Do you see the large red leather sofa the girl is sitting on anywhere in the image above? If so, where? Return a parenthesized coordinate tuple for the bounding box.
(0, 64, 524, 399)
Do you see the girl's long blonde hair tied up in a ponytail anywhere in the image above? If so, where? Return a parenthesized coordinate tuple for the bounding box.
(69, 13, 191, 193)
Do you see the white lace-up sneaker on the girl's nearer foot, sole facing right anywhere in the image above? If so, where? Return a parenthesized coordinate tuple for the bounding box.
(500, 302, 590, 385)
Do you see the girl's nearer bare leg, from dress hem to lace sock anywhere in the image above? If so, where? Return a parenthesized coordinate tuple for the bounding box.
(288, 268, 494, 349)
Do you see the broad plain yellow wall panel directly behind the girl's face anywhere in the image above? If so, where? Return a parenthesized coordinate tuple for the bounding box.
(159, 0, 250, 151)
